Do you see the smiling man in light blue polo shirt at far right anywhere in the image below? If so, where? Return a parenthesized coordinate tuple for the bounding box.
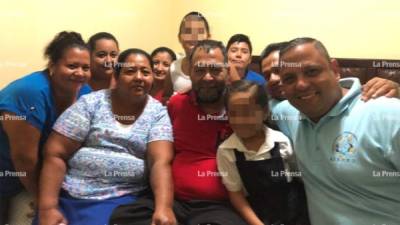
(272, 38, 400, 225)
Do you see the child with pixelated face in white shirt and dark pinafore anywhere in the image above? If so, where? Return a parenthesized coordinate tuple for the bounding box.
(217, 80, 308, 225)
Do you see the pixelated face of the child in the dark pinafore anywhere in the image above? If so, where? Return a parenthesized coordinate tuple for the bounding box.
(228, 91, 265, 138)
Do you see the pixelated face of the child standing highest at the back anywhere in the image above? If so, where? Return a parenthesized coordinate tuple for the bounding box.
(179, 16, 210, 56)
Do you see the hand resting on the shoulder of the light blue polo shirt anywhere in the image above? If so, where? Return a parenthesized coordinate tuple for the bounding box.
(361, 77, 400, 101)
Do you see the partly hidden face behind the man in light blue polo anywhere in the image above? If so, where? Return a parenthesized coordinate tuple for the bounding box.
(261, 51, 285, 99)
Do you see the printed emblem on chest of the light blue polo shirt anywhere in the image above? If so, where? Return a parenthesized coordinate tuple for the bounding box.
(331, 132, 358, 163)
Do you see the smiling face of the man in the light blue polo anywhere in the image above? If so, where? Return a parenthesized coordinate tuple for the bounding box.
(280, 43, 342, 122)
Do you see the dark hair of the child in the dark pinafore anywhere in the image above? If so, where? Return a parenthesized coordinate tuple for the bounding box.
(224, 80, 268, 109)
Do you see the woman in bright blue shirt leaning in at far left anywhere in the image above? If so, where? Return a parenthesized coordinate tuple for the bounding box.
(0, 31, 90, 222)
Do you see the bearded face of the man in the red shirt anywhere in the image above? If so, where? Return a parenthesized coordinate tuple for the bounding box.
(190, 48, 227, 103)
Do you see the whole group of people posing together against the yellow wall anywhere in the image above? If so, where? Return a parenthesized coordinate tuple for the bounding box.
(0, 12, 400, 225)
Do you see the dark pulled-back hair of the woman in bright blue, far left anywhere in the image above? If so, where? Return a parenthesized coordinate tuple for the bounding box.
(44, 31, 89, 63)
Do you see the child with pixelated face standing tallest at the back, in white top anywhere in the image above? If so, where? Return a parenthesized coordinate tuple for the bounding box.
(164, 12, 211, 98)
